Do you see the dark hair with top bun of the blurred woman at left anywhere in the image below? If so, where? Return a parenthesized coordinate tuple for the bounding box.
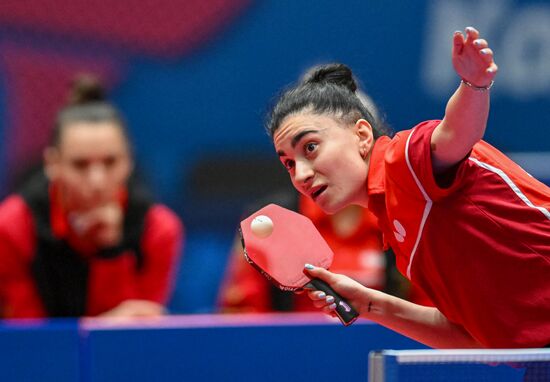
(51, 74, 129, 146)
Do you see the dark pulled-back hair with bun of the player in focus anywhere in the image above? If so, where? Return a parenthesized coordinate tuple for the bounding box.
(266, 64, 390, 139)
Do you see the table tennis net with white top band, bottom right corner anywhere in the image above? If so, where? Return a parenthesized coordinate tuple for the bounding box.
(369, 349, 550, 382)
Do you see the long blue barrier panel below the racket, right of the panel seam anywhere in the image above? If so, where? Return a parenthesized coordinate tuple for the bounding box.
(83, 314, 422, 382)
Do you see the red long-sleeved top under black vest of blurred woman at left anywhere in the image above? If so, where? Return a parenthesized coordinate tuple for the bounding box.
(0, 195, 183, 318)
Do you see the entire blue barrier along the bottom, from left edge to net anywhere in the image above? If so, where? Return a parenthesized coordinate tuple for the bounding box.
(0, 313, 423, 382)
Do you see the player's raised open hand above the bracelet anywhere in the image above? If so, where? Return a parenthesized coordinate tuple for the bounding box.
(452, 27, 498, 87)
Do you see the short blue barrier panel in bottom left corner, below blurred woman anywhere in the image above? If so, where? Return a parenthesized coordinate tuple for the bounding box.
(0, 320, 80, 382)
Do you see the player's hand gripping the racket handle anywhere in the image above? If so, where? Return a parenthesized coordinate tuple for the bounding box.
(305, 267, 370, 316)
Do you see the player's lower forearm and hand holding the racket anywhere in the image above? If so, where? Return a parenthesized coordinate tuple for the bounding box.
(308, 268, 481, 349)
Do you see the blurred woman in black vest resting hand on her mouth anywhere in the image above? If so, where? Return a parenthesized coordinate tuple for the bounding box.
(0, 76, 183, 318)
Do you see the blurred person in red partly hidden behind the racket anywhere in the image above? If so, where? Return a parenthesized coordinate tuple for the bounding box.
(218, 191, 430, 313)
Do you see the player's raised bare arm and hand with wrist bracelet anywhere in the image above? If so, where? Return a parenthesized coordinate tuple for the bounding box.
(431, 27, 498, 173)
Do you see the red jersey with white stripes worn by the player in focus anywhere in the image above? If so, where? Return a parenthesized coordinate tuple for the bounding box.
(368, 121, 550, 348)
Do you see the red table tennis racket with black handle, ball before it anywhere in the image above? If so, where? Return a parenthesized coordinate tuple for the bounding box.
(240, 204, 359, 326)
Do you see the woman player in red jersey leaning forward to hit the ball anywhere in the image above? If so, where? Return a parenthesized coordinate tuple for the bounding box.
(268, 28, 550, 348)
